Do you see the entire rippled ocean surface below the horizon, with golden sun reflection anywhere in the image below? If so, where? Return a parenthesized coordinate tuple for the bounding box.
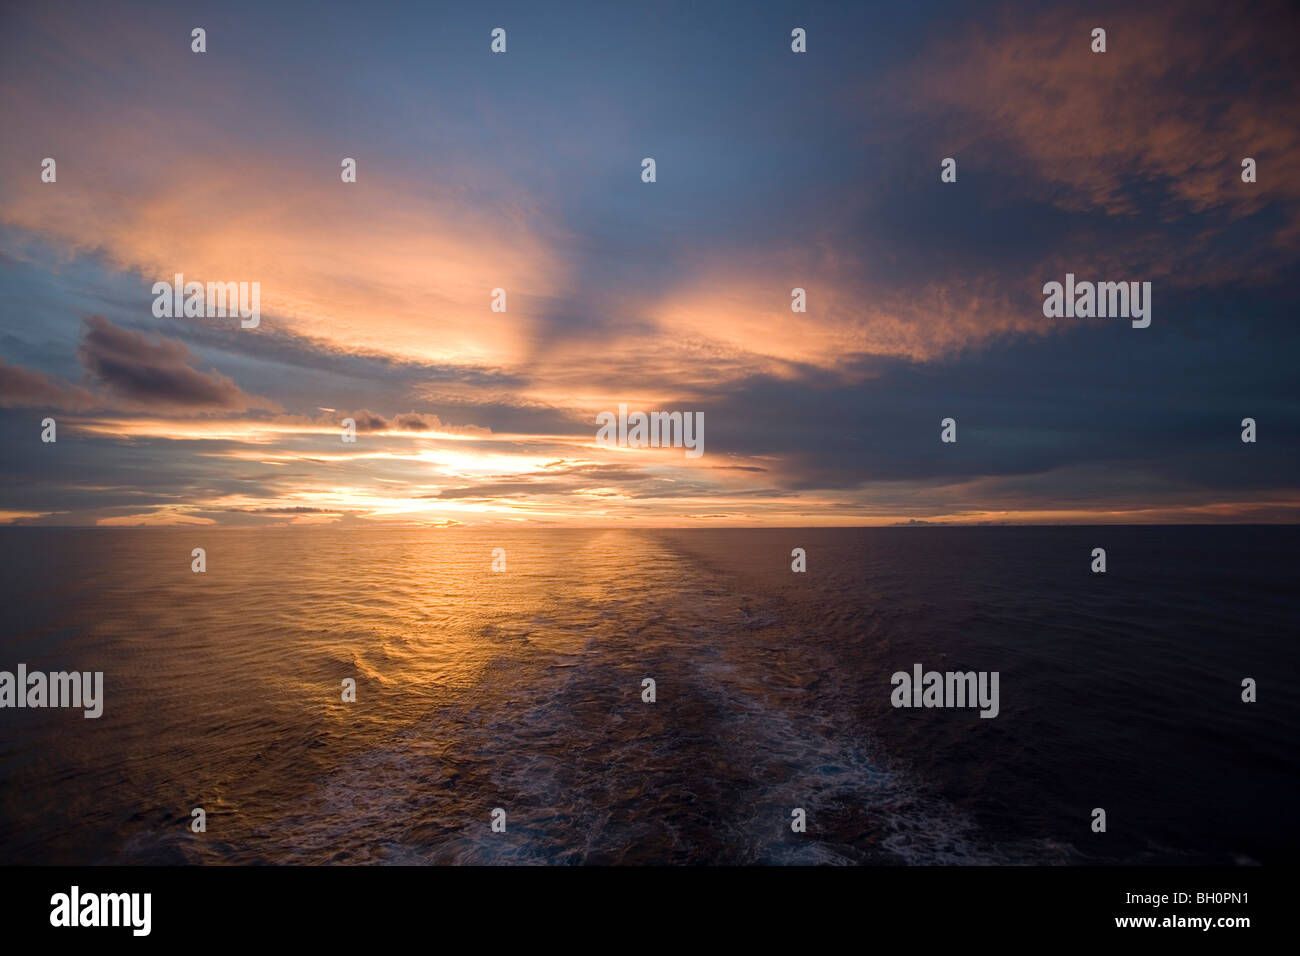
(0, 527, 1300, 865)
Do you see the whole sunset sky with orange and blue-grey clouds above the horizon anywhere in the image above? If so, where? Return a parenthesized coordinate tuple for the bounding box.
(0, 1, 1300, 527)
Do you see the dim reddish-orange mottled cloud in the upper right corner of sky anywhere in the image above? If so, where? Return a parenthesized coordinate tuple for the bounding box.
(904, 4, 1300, 228)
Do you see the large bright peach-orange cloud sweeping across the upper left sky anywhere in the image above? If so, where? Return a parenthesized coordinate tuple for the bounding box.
(0, 9, 564, 365)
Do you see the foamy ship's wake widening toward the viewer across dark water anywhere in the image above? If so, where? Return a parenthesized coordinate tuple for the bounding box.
(250, 538, 1056, 864)
